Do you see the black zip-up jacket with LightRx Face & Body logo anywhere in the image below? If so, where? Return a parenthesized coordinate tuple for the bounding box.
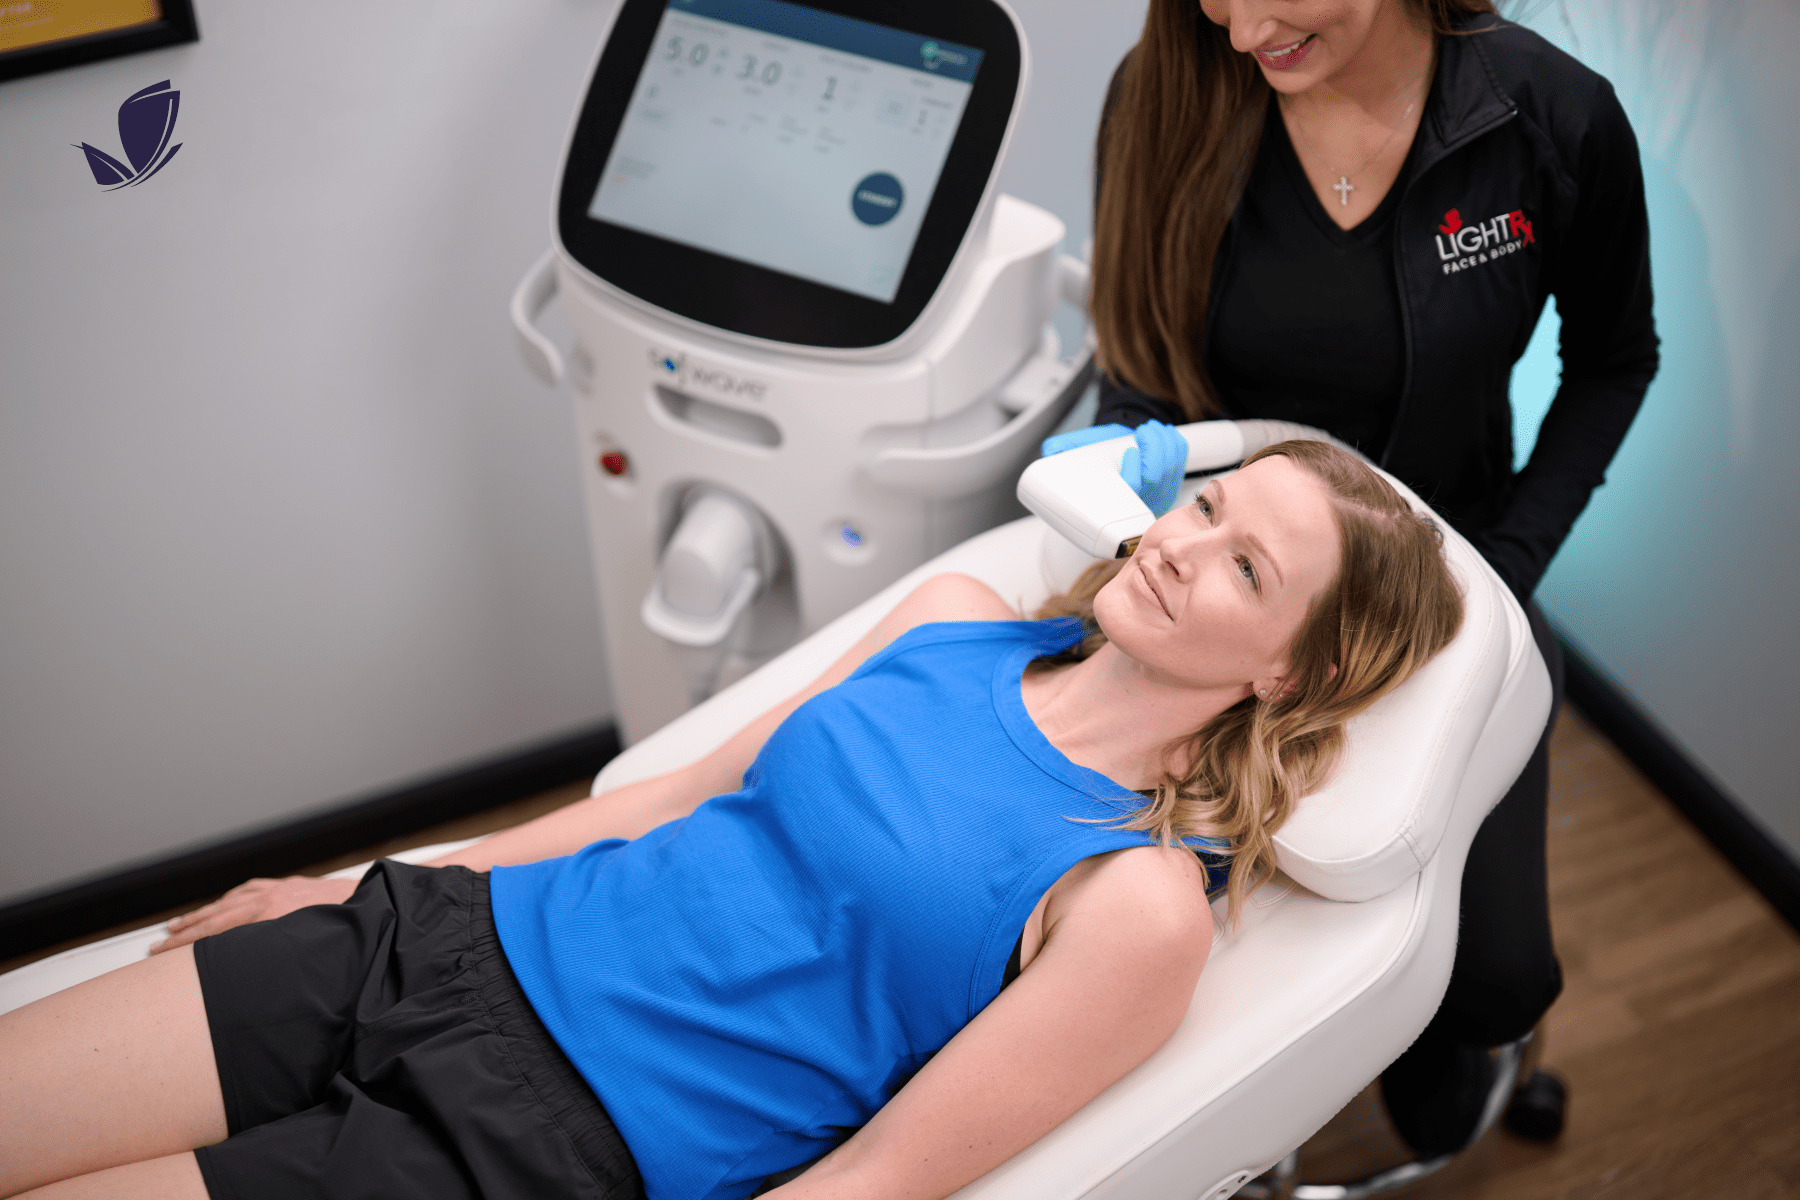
(1096, 14, 1656, 599)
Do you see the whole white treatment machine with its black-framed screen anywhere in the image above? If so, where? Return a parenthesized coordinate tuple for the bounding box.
(511, 0, 1093, 743)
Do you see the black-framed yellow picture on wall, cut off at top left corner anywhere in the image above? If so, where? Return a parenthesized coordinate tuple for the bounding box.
(0, 0, 200, 79)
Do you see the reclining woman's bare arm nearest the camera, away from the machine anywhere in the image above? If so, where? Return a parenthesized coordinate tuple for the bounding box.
(769, 847, 1213, 1200)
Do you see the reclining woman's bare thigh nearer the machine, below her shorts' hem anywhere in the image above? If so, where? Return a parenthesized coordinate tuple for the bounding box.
(0, 946, 227, 1196)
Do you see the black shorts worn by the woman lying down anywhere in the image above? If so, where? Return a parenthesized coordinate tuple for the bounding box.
(194, 862, 644, 1200)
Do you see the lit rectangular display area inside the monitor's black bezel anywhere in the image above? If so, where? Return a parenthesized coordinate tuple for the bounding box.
(587, 0, 981, 302)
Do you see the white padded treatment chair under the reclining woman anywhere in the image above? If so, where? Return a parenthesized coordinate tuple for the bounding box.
(0, 440, 1550, 1200)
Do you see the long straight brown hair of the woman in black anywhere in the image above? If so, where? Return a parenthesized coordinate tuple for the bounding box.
(1089, 0, 1494, 421)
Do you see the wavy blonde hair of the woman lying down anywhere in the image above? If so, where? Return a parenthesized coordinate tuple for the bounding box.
(1033, 441, 1463, 921)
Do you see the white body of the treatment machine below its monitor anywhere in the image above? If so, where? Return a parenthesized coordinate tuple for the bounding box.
(513, 196, 1087, 743)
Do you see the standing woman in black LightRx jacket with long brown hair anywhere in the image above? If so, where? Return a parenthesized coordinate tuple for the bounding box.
(1091, 0, 1656, 1157)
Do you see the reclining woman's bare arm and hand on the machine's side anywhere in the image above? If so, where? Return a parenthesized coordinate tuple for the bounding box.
(151, 576, 1017, 954)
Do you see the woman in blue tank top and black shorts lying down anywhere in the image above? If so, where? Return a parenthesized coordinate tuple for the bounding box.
(0, 443, 1462, 1200)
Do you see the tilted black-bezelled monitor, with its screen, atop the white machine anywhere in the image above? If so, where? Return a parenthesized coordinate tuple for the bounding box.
(556, 0, 1022, 347)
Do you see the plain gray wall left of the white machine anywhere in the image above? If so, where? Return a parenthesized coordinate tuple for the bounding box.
(0, 0, 610, 901)
